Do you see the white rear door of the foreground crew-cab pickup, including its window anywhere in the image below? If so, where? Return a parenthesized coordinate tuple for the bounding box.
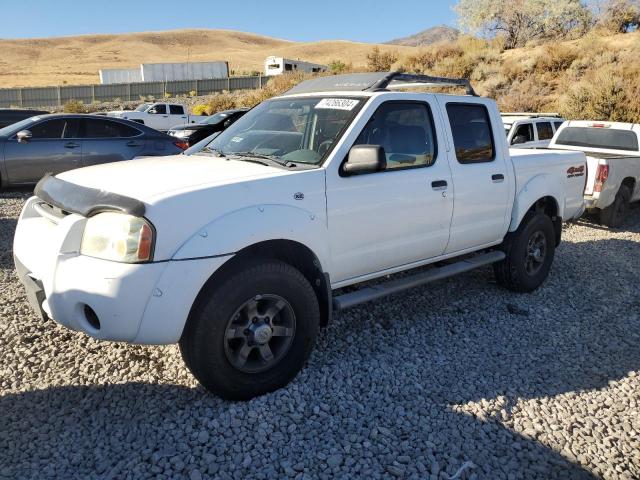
(440, 97, 514, 253)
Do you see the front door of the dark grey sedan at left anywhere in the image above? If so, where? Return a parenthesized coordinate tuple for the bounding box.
(4, 117, 82, 184)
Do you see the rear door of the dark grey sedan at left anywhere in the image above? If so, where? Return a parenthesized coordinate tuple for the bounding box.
(81, 117, 146, 166)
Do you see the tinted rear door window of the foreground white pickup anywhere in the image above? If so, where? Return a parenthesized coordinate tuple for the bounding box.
(447, 103, 495, 163)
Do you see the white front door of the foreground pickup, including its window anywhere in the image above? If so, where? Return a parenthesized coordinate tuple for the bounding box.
(327, 101, 453, 283)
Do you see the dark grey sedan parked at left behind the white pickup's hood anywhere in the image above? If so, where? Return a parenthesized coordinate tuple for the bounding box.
(0, 114, 186, 187)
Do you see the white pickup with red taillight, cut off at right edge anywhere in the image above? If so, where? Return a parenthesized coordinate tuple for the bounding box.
(549, 121, 640, 228)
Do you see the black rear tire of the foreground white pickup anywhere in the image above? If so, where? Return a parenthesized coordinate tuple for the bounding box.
(493, 212, 556, 293)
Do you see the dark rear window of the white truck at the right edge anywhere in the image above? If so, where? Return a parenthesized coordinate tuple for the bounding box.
(556, 127, 638, 152)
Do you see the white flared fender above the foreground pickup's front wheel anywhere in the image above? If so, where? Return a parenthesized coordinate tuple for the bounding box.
(172, 204, 330, 268)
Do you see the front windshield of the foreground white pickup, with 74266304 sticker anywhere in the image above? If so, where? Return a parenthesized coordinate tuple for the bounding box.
(196, 97, 366, 165)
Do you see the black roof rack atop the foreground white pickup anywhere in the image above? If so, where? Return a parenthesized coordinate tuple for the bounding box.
(285, 72, 477, 97)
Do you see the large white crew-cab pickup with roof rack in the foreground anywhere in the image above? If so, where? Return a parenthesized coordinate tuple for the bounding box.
(14, 73, 585, 399)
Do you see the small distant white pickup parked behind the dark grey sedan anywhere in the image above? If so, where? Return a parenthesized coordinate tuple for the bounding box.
(107, 103, 208, 132)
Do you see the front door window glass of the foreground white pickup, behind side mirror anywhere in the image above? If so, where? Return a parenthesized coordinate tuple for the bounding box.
(355, 102, 437, 170)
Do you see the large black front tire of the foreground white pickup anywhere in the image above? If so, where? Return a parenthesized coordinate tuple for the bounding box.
(180, 260, 320, 400)
